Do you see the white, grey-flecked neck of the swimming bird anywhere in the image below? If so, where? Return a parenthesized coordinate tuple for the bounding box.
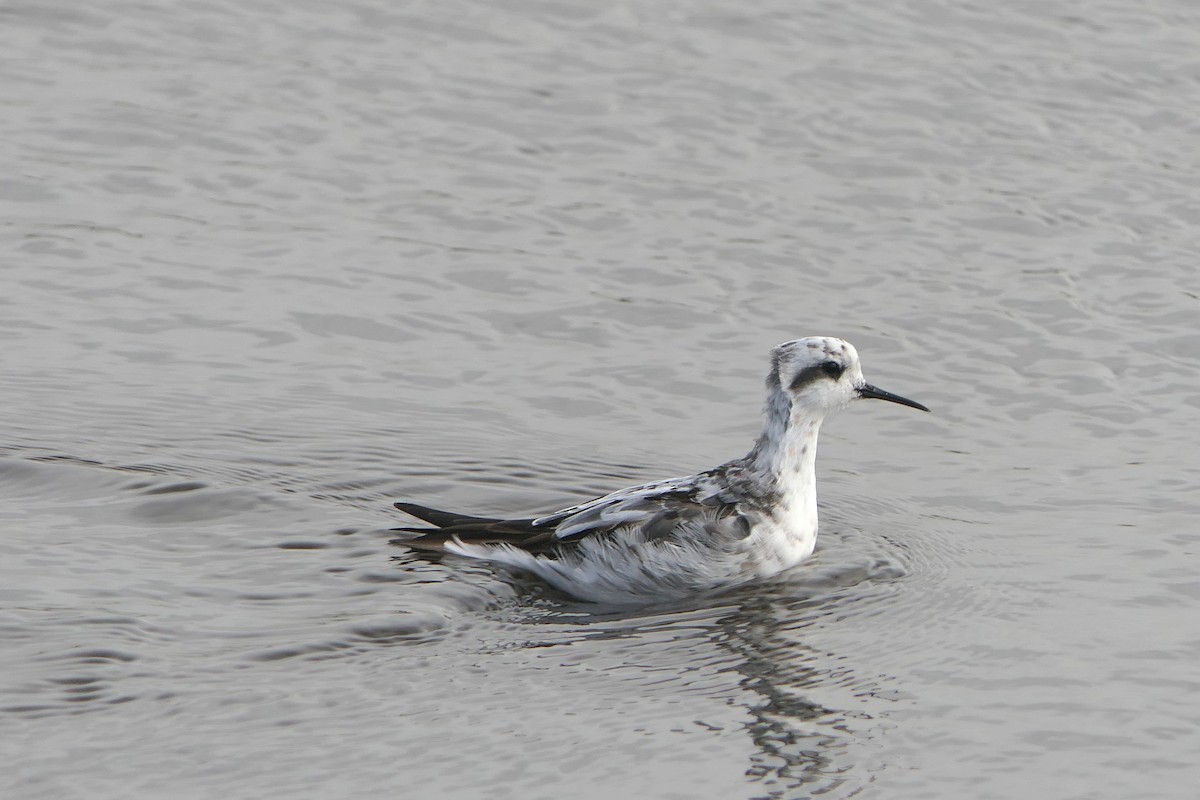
(744, 386, 823, 510)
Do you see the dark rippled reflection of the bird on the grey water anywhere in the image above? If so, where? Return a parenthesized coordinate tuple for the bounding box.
(511, 561, 902, 798)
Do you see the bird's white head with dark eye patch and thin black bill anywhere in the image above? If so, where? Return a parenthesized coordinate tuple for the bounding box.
(767, 336, 929, 417)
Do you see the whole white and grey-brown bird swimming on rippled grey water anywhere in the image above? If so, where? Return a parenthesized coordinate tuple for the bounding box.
(392, 336, 929, 606)
